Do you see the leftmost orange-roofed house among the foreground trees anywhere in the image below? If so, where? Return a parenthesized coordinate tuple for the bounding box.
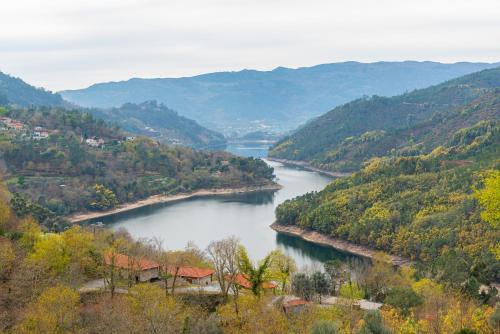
(104, 253, 160, 283)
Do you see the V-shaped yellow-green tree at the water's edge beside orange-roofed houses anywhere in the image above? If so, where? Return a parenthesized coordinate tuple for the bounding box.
(238, 246, 272, 296)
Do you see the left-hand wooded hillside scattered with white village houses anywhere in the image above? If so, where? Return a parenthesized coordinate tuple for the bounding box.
(0, 108, 273, 230)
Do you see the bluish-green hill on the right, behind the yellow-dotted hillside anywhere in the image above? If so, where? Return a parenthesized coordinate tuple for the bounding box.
(269, 67, 500, 171)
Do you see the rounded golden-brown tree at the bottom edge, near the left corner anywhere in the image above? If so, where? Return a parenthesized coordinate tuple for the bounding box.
(20, 285, 80, 334)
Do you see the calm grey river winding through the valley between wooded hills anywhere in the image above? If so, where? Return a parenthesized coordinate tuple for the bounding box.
(92, 146, 362, 269)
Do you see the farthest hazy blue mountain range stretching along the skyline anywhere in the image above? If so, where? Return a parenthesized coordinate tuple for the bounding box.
(61, 61, 498, 135)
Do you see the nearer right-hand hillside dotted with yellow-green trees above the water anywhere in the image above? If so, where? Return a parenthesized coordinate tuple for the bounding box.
(276, 118, 500, 289)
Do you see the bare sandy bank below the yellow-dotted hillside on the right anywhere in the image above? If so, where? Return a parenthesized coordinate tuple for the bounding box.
(270, 222, 413, 267)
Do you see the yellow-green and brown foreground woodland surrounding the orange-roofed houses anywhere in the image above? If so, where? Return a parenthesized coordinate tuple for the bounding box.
(0, 181, 500, 334)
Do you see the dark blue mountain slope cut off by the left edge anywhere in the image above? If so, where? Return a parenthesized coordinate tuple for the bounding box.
(0, 72, 68, 107)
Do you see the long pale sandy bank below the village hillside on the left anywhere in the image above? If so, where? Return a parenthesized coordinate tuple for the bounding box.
(67, 183, 283, 224)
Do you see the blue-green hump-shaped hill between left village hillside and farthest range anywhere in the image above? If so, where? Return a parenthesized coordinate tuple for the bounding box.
(88, 101, 226, 148)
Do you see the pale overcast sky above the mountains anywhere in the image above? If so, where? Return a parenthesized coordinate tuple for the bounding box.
(0, 0, 500, 91)
